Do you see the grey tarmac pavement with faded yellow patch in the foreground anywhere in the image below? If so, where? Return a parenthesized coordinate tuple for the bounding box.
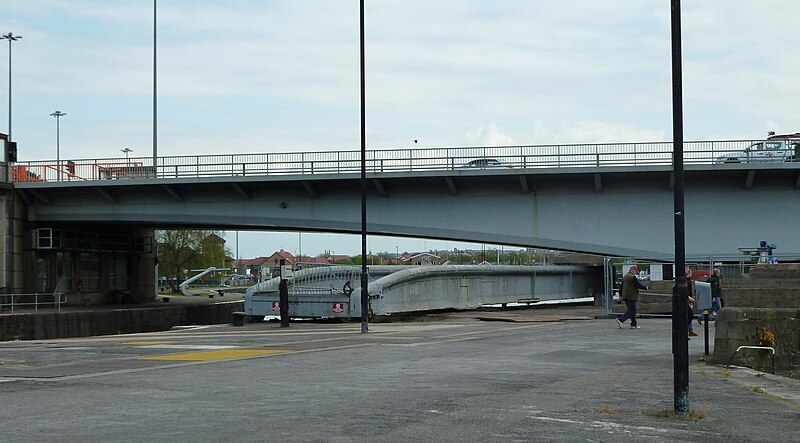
(0, 307, 800, 442)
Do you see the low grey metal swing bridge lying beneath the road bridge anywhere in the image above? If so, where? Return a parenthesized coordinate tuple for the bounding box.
(244, 265, 603, 318)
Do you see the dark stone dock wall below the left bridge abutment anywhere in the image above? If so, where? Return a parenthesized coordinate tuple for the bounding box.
(0, 301, 244, 341)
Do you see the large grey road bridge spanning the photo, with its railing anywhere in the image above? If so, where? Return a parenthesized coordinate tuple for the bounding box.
(3, 140, 800, 304)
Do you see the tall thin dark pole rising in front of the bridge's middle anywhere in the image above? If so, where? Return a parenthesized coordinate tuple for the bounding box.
(360, 0, 369, 333)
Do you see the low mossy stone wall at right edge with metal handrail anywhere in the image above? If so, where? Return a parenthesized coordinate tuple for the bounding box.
(713, 307, 800, 378)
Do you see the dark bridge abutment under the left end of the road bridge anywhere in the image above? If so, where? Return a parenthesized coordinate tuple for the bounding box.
(0, 184, 157, 308)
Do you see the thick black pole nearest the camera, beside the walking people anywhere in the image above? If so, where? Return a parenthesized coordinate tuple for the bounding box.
(672, 0, 689, 415)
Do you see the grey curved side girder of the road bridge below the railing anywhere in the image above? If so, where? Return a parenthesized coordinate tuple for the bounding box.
(18, 164, 800, 259)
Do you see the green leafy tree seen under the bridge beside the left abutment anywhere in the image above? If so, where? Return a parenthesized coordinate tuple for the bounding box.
(156, 229, 230, 292)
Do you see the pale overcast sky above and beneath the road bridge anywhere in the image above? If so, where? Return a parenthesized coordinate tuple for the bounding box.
(0, 0, 800, 257)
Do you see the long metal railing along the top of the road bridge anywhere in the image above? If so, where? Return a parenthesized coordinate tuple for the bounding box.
(12, 140, 800, 182)
